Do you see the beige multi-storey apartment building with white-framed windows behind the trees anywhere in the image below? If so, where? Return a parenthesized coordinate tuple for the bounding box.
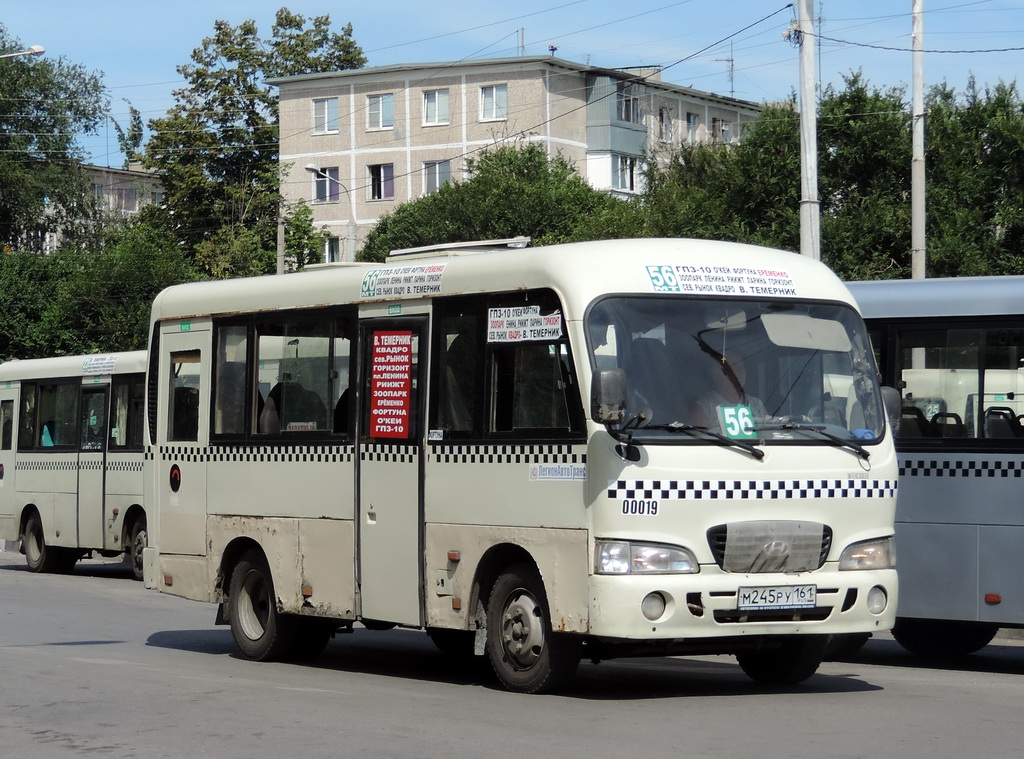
(269, 56, 759, 261)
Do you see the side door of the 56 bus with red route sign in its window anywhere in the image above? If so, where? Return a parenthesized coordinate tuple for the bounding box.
(356, 317, 427, 626)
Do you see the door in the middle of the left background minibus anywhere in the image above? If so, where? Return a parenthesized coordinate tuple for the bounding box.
(78, 384, 108, 550)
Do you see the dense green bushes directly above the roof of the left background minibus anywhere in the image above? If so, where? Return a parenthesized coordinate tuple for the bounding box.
(0, 222, 197, 360)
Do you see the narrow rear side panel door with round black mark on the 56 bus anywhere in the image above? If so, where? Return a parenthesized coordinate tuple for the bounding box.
(155, 322, 211, 556)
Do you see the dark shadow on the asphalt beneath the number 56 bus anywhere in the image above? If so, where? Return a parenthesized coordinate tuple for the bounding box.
(147, 628, 881, 701)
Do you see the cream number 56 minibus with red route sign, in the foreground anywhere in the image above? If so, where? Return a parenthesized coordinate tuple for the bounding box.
(143, 239, 897, 692)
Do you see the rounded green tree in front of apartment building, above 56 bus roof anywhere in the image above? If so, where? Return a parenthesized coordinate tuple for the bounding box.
(359, 142, 617, 261)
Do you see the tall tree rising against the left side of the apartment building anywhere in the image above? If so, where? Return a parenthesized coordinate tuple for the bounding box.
(145, 8, 366, 277)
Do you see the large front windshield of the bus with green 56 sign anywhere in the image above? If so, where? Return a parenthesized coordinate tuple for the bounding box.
(587, 296, 885, 445)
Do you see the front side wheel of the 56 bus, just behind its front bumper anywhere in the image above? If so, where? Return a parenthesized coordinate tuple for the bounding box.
(486, 564, 581, 693)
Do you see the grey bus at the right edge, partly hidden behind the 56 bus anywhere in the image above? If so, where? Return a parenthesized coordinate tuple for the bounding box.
(849, 277, 1024, 657)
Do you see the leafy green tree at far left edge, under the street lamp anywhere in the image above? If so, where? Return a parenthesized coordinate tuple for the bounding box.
(0, 26, 108, 250)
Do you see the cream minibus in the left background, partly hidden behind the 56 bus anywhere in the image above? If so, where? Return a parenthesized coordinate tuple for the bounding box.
(0, 350, 146, 580)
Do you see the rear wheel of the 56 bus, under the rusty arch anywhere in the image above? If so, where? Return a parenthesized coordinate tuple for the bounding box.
(227, 550, 296, 662)
